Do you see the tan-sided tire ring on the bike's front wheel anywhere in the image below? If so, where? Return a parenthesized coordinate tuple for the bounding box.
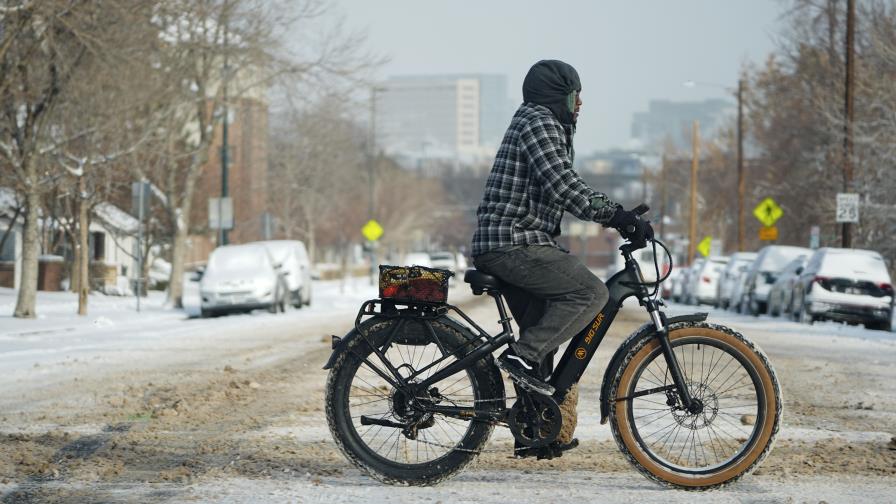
(614, 327, 778, 487)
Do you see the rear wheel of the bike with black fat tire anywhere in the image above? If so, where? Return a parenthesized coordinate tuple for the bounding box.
(326, 319, 504, 485)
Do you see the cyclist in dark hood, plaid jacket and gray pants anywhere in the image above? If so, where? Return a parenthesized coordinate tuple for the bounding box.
(472, 60, 653, 395)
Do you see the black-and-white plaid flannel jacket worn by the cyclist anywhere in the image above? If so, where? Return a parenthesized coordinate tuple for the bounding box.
(472, 103, 618, 256)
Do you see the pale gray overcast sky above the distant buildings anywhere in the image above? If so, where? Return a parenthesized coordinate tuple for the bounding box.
(337, 0, 786, 153)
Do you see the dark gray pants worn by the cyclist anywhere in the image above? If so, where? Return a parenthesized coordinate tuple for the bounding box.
(473, 245, 610, 362)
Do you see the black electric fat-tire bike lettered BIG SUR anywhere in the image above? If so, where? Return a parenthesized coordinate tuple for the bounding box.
(324, 216, 782, 490)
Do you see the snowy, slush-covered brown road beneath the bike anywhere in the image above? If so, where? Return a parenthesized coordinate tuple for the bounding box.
(0, 286, 896, 503)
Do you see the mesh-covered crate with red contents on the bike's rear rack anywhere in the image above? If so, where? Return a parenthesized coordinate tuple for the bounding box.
(380, 265, 454, 303)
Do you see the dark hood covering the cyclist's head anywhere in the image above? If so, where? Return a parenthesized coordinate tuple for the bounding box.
(523, 60, 582, 125)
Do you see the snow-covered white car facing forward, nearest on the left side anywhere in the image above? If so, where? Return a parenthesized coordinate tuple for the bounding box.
(199, 243, 288, 317)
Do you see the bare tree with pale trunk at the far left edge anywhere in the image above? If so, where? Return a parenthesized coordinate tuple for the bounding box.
(0, 1, 109, 318)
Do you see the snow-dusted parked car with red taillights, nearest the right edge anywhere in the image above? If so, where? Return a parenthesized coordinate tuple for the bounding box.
(793, 247, 893, 331)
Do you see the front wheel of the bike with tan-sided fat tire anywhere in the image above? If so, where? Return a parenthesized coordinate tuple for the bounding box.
(610, 323, 782, 490)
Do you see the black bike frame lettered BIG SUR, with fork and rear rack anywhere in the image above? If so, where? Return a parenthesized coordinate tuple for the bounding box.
(338, 246, 695, 421)
